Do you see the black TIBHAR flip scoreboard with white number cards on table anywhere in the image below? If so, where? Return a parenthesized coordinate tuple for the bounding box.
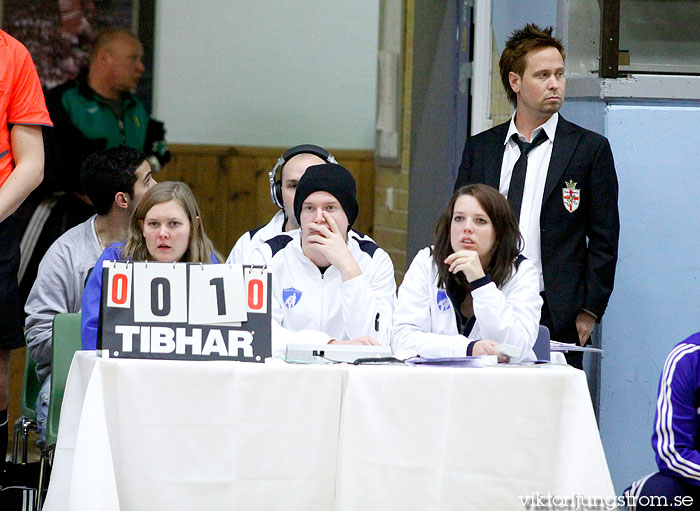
(96, 261, 272, 362)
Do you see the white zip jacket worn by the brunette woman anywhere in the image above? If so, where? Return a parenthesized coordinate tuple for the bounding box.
(392, 247, 542, 362)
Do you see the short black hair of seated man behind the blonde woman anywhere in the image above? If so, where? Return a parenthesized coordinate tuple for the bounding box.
(80, 146, 146, 215)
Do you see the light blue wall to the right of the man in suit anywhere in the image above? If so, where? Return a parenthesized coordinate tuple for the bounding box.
(562, 100, 700, 494)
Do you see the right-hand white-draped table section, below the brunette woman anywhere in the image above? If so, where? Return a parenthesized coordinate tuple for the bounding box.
(335, 365, 615, 511)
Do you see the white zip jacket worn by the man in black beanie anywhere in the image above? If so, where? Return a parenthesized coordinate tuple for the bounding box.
(254, 230, 396, 356)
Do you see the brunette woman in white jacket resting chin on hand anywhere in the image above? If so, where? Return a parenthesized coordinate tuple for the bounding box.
(392, 184, 542, 362)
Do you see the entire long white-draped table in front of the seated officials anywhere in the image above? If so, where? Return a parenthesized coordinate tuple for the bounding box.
(44, 352, 614, 511)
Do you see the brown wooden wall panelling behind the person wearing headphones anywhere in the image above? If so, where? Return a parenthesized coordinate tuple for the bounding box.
(155, 144, 374, 256)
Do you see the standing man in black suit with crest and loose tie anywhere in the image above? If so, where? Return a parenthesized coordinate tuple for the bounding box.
(455, 25, 620, 367)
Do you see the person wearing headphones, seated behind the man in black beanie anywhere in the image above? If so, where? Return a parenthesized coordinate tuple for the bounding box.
(226, 144, 337, 264)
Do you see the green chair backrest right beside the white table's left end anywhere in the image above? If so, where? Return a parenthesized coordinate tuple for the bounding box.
(46, 312, 82, 446)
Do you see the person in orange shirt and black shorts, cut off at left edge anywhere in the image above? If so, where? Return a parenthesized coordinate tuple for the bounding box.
(0, 30, 52, 469)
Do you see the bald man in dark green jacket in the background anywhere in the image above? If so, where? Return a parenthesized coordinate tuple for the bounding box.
(46, 29, 170, 214)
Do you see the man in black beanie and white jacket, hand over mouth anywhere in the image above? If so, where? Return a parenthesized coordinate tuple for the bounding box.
(251, 163, 396, 356)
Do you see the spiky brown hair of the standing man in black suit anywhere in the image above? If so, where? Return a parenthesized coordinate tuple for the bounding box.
(498, 23, 565, 107)
